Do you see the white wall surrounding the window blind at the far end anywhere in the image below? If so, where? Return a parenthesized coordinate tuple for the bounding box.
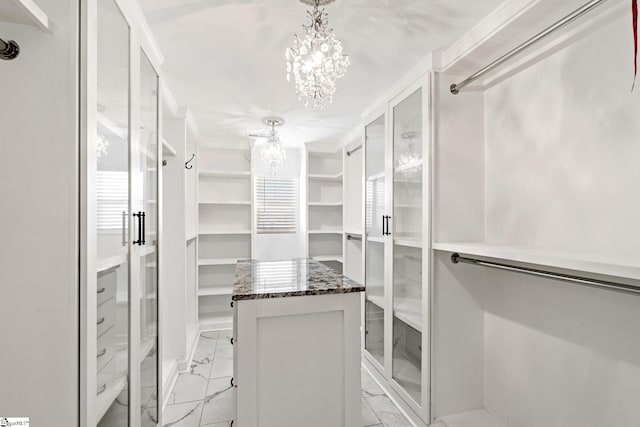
(251, 145, 307, 260)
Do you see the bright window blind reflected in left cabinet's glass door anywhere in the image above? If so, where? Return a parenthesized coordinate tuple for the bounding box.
(96, 171, 129, 232)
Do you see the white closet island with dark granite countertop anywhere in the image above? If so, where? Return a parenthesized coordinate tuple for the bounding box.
(232, 258, 364, 427)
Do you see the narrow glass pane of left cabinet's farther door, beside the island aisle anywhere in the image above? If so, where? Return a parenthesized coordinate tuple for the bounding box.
(138, 51, 159, 427)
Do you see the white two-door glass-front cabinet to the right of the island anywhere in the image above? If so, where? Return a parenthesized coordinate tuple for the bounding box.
(363, 75, 431, 423)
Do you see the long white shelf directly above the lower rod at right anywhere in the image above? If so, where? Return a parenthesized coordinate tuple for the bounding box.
(433, 242, 640, 280)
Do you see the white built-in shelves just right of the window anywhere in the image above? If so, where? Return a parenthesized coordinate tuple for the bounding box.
(307, 150, 344, 273)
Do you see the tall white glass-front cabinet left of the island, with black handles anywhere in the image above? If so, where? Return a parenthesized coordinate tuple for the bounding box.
(80, 0, 164, 427)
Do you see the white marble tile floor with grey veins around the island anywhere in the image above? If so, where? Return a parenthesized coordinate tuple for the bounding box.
(164, 331, 412, 427)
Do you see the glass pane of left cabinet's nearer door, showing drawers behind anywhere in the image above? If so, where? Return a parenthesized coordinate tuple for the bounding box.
(93, 0, 131, 427)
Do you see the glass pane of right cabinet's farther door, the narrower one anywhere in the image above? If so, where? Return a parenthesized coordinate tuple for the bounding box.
(364, 115, 386, 366)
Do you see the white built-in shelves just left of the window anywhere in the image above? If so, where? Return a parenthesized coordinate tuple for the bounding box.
(198, 147, 253, 330)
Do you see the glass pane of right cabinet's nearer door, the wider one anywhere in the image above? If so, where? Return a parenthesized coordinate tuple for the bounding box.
(392, 89, 424, 404)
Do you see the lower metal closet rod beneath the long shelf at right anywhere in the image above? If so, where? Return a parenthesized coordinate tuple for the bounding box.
(451, 253, 640, 294)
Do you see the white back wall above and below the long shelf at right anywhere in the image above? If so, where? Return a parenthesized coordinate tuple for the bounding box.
(482, 10, 640, 427)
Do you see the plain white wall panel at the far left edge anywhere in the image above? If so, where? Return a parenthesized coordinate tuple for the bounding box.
(0, 0, 79, 426)
